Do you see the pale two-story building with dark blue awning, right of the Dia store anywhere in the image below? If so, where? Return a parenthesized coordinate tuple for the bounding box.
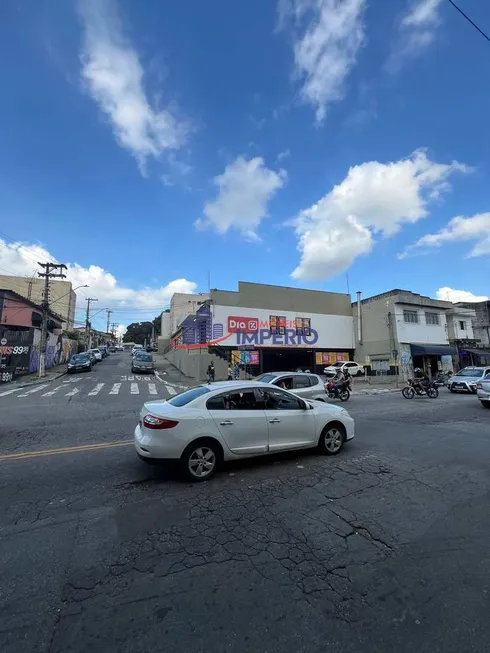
(353, 289, 473, 378)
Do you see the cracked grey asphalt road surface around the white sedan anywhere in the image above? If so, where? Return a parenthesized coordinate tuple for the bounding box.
(0, 354, 490, 653)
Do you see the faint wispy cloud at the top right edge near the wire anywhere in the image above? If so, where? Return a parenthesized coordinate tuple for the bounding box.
(387, 0, 443, 72)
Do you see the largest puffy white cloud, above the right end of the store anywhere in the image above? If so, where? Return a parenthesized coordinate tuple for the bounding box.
(292, 150, 469, 281)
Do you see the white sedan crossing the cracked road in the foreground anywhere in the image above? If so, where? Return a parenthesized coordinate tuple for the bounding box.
(134, 381, 354, 481)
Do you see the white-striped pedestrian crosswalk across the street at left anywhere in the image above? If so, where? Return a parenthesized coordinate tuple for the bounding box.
(0, 377, 187, 400)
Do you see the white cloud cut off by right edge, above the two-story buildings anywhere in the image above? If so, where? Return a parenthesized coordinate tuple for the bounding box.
(399, 213, 490, 258)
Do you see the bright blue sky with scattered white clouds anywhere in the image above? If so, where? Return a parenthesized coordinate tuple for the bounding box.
(0, 0, 490, 328)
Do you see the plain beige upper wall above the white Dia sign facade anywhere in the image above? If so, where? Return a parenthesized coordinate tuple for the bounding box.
(211, 281, 352, 316)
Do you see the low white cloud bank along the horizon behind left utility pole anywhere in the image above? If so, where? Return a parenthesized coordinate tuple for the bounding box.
(0, 239, 197, 313)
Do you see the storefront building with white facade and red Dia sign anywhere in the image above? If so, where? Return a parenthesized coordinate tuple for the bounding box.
(172, 282, 354, 375)
